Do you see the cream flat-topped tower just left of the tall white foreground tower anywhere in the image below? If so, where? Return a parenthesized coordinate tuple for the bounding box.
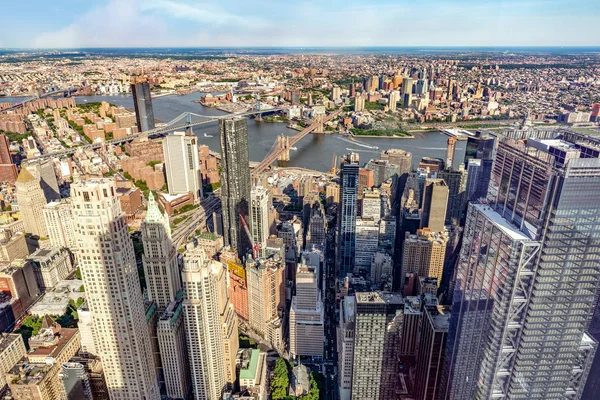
(42, 200, 77, 252)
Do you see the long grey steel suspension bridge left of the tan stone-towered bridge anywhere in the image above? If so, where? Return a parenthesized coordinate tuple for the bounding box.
(32, 107, 285, 160)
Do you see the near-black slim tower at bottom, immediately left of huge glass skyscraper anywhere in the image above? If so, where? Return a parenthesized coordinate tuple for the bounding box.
(415, 306, 450, 400)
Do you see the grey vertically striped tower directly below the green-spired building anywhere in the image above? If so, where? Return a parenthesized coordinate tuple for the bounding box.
(156, 292, 192, 399)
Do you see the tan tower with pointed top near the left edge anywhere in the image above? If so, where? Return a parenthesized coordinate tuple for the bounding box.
(15, 168, 48, 237)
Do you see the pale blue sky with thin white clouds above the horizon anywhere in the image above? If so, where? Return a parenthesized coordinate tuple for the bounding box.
(0, 0, 600, 48)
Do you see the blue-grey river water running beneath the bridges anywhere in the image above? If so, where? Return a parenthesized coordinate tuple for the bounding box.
(0, 93, 466, 171)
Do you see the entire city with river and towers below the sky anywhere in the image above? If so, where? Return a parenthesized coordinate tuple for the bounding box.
(0, 48, 600, 400)
